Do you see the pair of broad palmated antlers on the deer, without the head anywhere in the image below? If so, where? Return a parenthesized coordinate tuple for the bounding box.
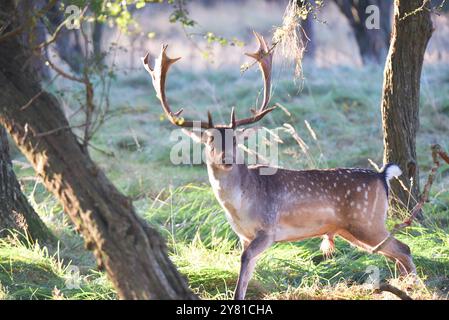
(142, 32, 276, 129)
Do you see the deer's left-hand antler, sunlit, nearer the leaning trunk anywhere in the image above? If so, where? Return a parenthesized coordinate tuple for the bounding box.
(142, 44, 212, 129)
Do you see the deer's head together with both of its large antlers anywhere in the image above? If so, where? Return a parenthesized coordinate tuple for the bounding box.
(142, 32, 275, 170)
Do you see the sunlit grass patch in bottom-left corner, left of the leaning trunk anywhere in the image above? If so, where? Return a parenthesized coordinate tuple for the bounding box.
(0, 237, 115, 300)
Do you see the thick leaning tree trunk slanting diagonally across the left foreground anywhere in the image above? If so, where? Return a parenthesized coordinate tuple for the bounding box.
(0, 0, 196, 299)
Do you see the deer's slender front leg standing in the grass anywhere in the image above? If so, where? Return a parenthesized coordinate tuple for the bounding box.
(234, 231, 273, 300)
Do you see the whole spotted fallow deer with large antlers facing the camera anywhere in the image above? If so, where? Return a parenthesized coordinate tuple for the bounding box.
(142, 33, 415, 299)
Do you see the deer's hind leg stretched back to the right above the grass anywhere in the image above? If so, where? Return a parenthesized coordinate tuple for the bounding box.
(339, 229, 416, 275)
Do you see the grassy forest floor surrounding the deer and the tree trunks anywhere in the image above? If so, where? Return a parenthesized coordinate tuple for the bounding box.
(0, 58, 449, 299)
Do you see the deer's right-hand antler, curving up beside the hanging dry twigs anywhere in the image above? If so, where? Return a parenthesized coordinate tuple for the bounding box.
(229, 31, 276, 126)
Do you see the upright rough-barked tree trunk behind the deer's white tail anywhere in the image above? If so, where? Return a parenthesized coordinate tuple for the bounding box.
(381, 0, 432, 208)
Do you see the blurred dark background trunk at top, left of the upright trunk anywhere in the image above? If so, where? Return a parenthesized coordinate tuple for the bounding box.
(334, 0, 391, 64)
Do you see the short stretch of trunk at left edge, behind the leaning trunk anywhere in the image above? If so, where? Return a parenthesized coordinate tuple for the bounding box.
(0, 126, 55, 244)
